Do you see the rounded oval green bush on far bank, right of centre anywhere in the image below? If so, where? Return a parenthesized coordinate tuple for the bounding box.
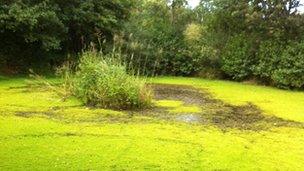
(221, 35, 255, 80)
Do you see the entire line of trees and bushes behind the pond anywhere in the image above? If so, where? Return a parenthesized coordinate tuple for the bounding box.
(0, 0, 304, 88)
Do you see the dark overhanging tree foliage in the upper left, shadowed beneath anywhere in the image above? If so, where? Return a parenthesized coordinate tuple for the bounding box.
(0, 0, 131, 70)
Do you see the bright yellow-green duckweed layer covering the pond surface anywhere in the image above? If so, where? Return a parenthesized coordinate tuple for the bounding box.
(0, 77, 304, 170)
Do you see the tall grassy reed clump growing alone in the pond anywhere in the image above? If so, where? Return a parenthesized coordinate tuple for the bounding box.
(62, 51, 152, 109)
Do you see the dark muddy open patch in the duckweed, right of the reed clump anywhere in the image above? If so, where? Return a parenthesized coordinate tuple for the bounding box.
(150, 84, 304, 131)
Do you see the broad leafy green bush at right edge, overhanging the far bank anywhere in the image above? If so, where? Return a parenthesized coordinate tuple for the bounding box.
(254, 40, 304, 88)
